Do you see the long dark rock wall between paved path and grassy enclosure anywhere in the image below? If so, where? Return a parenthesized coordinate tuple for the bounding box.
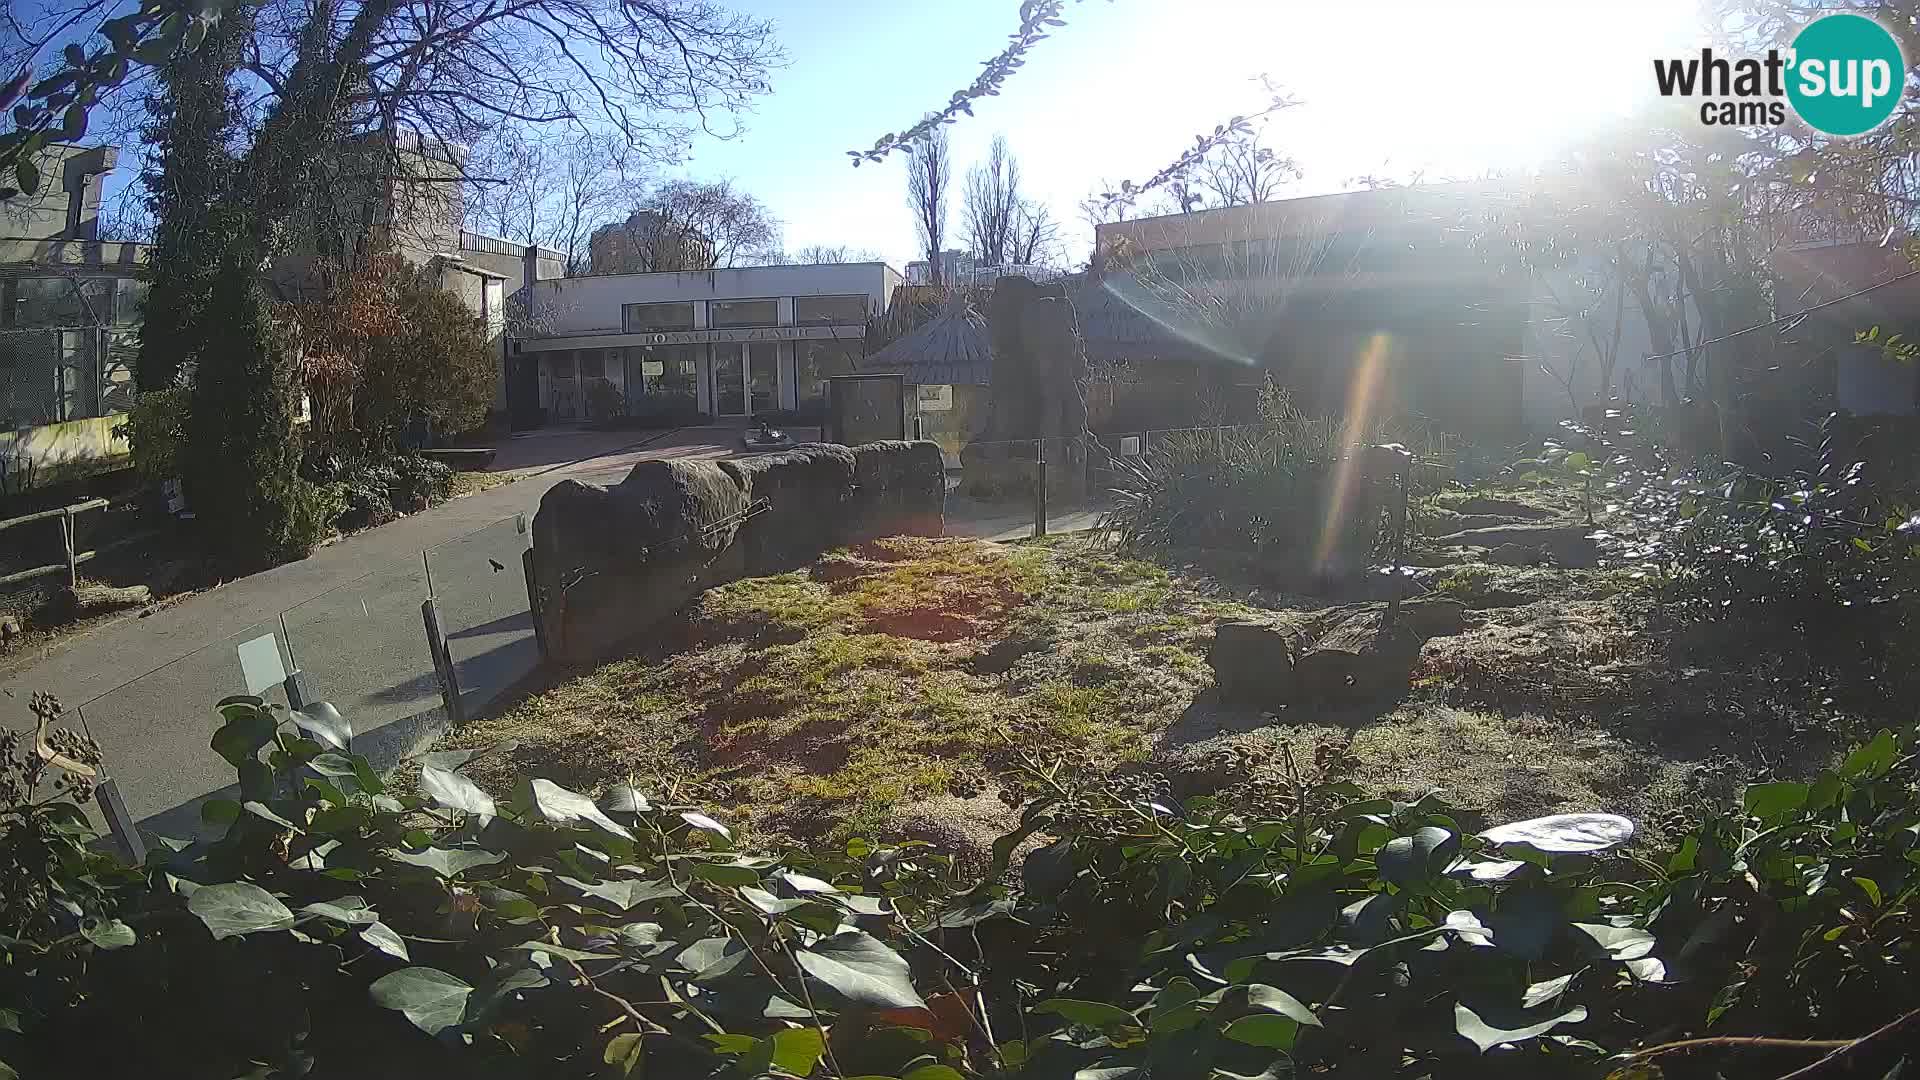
(534, 442, 947, 665)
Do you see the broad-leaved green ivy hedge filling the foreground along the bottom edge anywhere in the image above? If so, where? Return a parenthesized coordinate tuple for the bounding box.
(0, 698, 1920, 1080)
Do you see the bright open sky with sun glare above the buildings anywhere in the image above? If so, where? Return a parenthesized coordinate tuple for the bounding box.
(682, 0, 1705, 267)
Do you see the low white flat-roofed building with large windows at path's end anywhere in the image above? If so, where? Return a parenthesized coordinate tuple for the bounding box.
(511, 263, 900, 421)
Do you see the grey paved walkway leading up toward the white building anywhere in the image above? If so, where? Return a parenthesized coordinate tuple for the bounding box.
(0, 429, 1092, 836)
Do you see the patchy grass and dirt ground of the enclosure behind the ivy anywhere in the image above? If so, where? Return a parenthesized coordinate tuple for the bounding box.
(449, 476, 1843, 851)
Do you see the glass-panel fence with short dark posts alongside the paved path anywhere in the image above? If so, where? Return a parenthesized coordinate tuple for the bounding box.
(67, 515, 540, 849)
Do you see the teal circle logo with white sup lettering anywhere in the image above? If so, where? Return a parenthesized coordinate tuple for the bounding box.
(1788, 15, 1907, 135)
